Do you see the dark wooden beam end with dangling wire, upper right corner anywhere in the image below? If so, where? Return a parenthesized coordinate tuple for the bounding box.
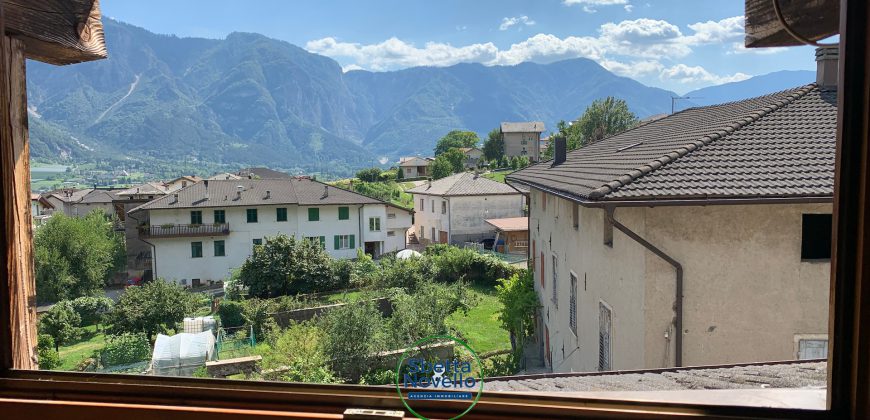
(745, 0, 840, 48)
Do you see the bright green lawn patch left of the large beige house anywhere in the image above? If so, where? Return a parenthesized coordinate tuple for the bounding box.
(447, 285, 511, 354)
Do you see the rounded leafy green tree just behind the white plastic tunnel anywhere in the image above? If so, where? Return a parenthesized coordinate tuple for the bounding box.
(108, 279, 196, 341)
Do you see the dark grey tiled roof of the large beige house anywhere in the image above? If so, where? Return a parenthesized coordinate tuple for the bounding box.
(507, 85, 837, 201)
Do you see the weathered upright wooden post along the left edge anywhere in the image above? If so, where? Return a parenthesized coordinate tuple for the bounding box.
(0, 31, 36, 369)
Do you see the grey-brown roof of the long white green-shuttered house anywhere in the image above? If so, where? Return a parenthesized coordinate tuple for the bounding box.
(130, 178, 391, 213)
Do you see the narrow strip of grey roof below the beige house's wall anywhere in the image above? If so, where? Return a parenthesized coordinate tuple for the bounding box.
(486, 361, 827, 392)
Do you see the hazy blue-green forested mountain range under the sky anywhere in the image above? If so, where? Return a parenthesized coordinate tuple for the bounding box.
(27, 19, 809, 175)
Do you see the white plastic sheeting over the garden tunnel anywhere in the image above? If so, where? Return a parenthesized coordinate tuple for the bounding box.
(151, 331, 215, 376)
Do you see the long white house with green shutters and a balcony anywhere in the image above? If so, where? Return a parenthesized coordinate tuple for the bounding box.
(128, 177, 411, 286)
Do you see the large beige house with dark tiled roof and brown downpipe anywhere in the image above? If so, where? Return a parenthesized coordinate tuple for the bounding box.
(507, 51, 837, 372)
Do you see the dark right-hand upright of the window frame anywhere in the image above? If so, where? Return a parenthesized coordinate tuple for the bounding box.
(827, 0, 870, 419)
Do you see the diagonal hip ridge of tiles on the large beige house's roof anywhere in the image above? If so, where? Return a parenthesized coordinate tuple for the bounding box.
(587, 83, 817, 200)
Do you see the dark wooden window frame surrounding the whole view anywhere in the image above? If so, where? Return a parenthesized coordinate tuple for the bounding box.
(0, 0, 870, 419)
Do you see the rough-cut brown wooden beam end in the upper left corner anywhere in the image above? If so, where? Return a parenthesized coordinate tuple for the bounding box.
(3, 0, 107, 65)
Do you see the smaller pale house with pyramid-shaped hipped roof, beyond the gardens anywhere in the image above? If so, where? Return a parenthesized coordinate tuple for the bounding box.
(408, 172, 524, 244)
